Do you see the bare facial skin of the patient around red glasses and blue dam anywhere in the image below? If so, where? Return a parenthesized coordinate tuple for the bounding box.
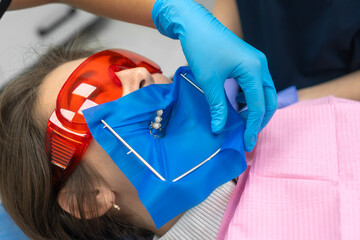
(35, 59, 171, 220)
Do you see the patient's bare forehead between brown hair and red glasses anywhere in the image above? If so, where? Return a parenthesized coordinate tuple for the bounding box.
(35, 58, 86, 123)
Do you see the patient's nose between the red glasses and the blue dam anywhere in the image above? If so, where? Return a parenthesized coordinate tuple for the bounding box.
(116, 67, 154, 95)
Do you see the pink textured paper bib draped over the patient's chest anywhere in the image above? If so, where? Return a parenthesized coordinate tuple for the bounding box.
(218, 97, 360, 240)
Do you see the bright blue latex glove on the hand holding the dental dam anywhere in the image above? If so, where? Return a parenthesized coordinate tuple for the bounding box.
(152, 0, 277, 151)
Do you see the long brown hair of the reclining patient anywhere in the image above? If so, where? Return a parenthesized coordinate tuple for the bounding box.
(0, 41, 149, 240)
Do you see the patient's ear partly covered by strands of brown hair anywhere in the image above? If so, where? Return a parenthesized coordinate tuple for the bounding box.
(58, 186, 115, 219)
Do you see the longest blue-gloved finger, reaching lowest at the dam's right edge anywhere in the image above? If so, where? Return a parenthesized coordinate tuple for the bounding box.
(237, 77, 265, 152)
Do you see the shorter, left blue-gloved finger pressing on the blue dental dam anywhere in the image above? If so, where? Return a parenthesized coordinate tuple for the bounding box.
(202, 84, 228, 133)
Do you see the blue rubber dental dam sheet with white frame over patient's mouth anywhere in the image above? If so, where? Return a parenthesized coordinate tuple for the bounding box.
(83, 67, 246, 228)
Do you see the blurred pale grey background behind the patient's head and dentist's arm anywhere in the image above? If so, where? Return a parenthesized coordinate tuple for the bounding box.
(0, 0, 215, 84)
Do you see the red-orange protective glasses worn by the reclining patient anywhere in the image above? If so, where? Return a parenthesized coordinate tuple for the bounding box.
(46, 49, 161, 191)
